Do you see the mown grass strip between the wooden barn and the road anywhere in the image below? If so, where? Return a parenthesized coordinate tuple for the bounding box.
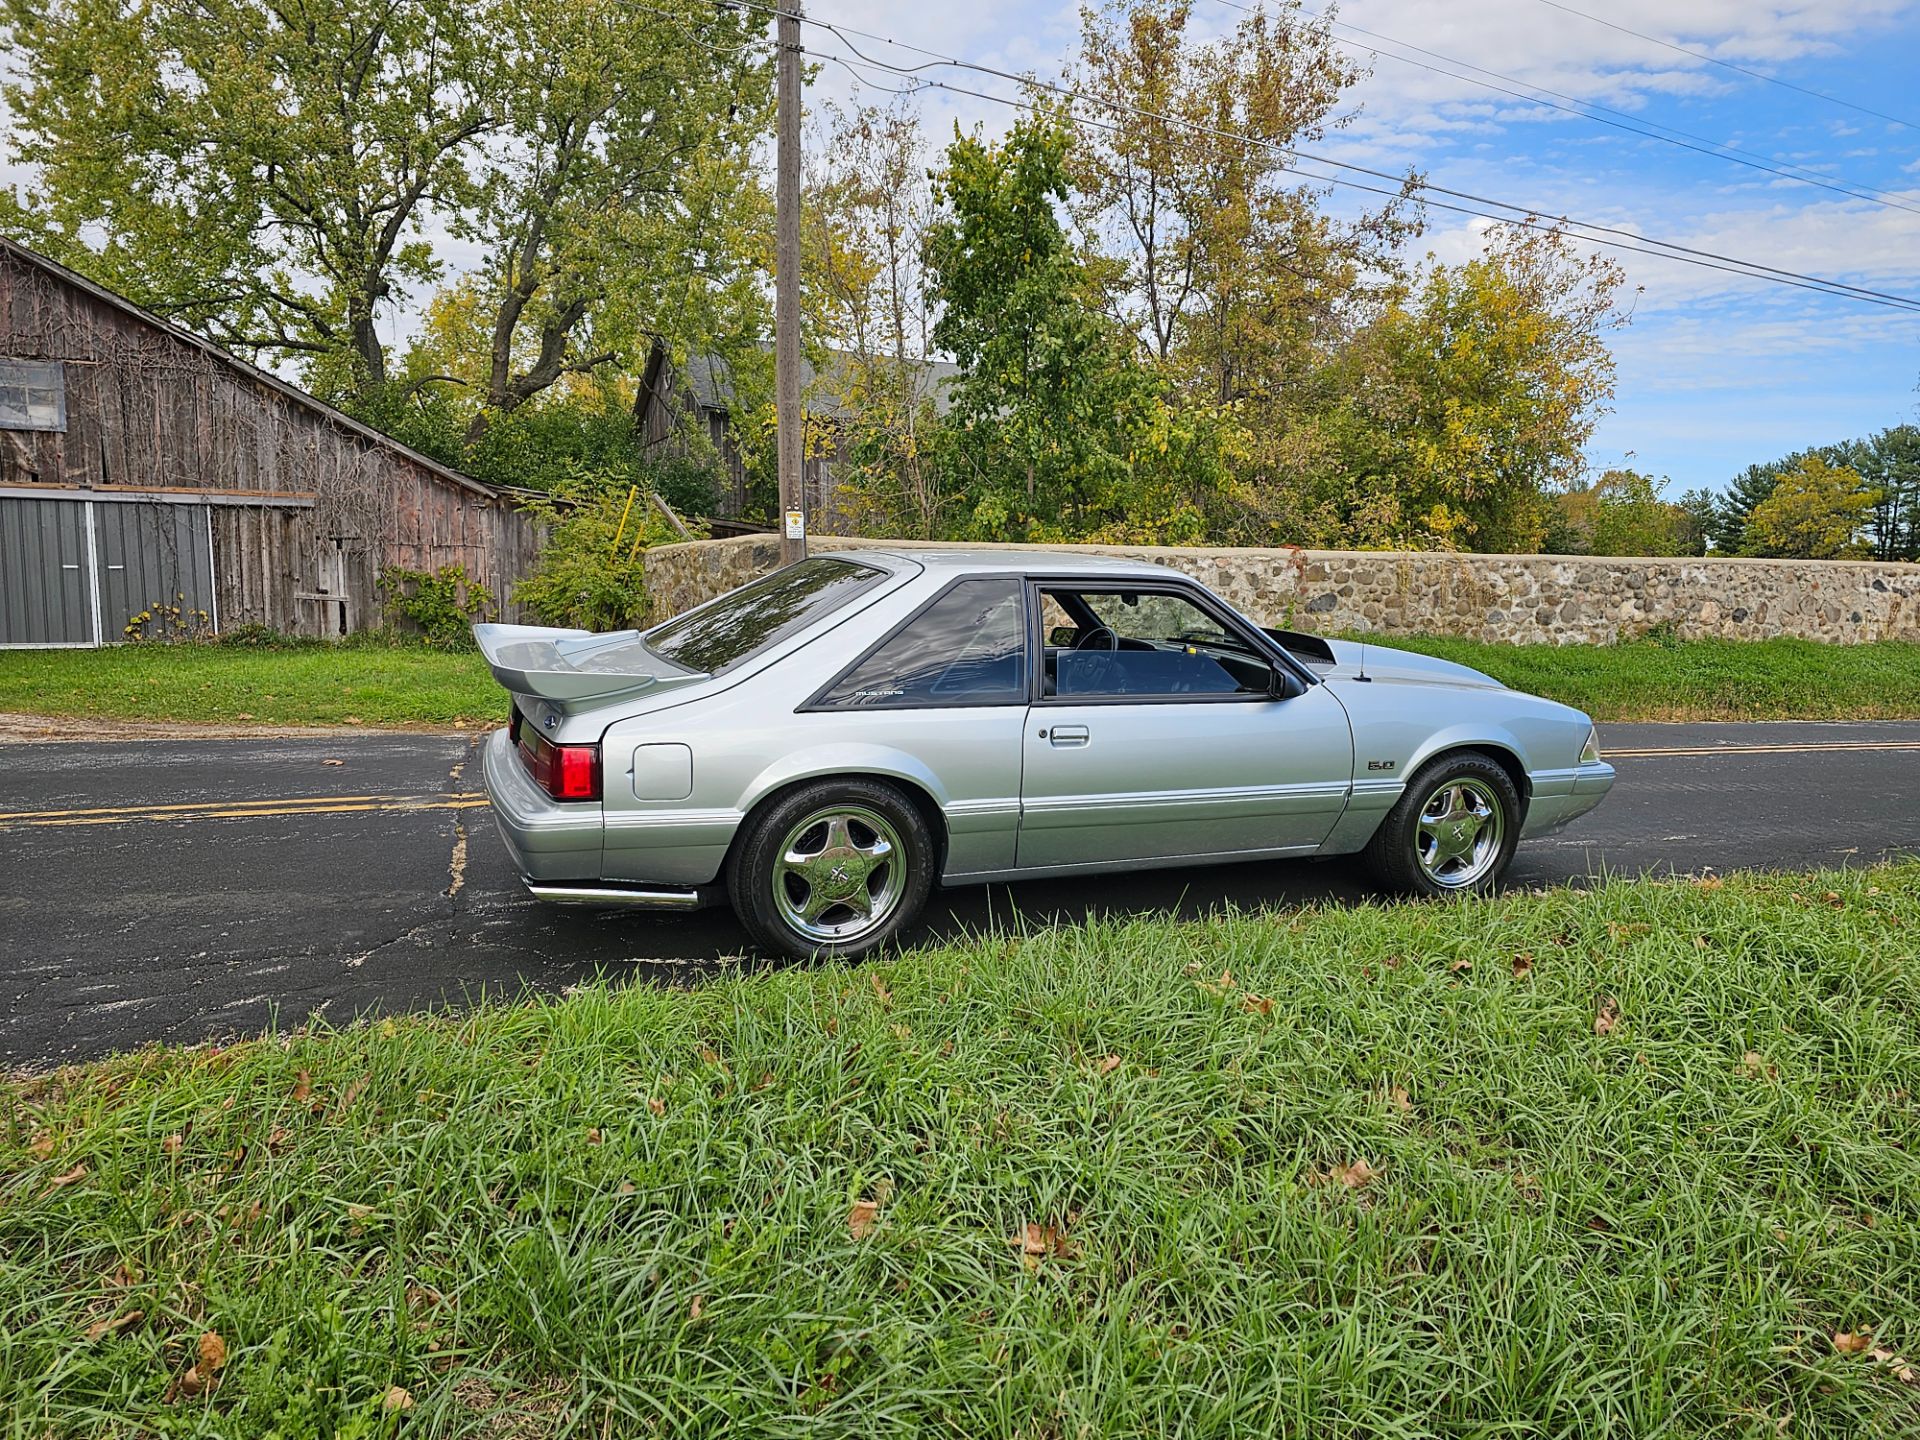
(0, 641, 507, 726)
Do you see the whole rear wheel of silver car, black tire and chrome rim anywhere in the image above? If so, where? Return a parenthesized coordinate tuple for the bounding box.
(728, 780, 935, 960)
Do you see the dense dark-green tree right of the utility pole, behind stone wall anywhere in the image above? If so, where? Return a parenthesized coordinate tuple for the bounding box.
(925, 115, 1127, 540)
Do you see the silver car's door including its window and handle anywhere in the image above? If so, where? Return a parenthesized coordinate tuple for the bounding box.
(1018, 582, 1354, 870)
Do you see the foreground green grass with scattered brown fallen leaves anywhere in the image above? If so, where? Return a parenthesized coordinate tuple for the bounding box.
(0, 864, 1920, 1440)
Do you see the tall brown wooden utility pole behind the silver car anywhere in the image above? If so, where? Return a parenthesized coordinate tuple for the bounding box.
(774, 0, 806, 564)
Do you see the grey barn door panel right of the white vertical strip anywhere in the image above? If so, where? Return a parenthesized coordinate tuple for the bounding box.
(94, 501, 213, 641)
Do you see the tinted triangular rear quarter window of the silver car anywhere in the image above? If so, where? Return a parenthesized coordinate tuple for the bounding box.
(818, 580, 1027, 708)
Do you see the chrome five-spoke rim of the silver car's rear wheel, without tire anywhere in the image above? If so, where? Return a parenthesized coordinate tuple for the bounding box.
(774, 804, 906, 945)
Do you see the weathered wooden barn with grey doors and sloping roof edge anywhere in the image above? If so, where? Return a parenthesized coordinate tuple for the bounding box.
(0, 240, 541, 645)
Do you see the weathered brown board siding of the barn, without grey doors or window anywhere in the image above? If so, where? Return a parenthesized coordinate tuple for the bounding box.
(0, 242, 543, 636)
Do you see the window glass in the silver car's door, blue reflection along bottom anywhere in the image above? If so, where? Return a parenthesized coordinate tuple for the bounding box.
(1043, 589, 1273, 701)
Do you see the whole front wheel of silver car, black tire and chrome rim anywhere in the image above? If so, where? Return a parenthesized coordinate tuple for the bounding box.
(1365, 751, 1521, 895)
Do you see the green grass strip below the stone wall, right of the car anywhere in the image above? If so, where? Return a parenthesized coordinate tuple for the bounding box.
(1374, 636, 1920, 720)
